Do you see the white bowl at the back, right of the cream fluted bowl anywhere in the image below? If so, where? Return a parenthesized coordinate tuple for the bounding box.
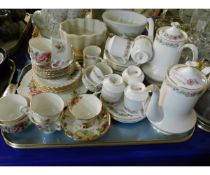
(102, 10, 147, 38)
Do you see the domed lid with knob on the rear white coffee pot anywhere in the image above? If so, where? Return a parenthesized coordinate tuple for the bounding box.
(159, 22, 187, 42)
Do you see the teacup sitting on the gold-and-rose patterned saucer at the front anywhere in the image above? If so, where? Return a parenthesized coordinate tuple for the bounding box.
(68, 94, 102, 128)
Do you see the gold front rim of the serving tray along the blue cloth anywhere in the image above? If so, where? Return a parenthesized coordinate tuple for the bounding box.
(1, 127, 195, 149)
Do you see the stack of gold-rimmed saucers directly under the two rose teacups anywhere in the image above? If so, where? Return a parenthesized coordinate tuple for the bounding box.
(32, 60, 76, 79)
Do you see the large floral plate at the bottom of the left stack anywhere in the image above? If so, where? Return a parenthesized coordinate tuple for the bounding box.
(17, 70, 87, 106)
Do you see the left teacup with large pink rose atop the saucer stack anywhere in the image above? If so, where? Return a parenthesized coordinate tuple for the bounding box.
(29, 37, 52, 66)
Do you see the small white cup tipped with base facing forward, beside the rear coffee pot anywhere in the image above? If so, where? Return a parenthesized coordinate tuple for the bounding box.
(131, 35, 153, 64)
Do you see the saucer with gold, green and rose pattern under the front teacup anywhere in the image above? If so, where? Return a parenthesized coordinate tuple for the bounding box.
(61, 110, 111, 141)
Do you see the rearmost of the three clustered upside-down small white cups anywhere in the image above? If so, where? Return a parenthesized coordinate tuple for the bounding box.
(122, 66, 144, 84)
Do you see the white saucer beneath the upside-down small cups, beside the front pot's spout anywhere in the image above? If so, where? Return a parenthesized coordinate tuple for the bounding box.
(101, 97, 146, 123)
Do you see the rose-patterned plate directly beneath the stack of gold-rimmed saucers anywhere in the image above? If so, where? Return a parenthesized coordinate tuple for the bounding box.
(33, 63, 82, 88)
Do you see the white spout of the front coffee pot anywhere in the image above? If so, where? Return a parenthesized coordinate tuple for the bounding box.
(146, 85, 164, 122)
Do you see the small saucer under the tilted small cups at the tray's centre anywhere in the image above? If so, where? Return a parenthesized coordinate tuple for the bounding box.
(82, 67, 102, 92)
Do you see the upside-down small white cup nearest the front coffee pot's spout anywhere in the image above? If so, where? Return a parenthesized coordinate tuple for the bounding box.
(124, 82, 149, 114)
